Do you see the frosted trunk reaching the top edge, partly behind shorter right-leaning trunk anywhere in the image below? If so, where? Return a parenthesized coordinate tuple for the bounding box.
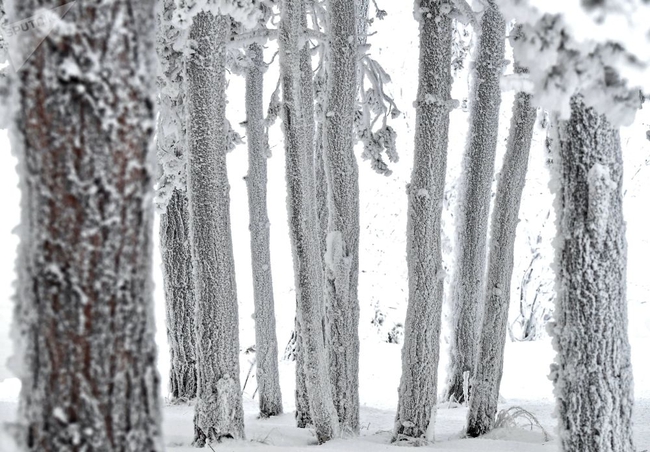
(445, 0, 505, 402)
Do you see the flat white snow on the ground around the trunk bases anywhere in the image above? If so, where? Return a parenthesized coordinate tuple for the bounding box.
(0, 340, 650, 452)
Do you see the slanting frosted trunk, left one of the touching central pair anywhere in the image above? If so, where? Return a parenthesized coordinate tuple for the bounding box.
(279, 0, 339, 443)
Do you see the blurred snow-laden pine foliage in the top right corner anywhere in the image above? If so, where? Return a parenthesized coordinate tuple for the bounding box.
(498, 0, 650, 125)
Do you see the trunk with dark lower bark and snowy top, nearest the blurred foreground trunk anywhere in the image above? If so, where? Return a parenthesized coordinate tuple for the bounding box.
(156, 0, 196, 401)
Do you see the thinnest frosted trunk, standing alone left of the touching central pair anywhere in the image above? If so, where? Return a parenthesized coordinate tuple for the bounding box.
(246, 44, 282, 417)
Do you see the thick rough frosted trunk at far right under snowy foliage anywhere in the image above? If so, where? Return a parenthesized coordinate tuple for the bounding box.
(551, 96, 634, 452)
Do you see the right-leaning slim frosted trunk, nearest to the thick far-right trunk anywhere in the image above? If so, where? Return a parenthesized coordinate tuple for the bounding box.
(467, 65, 537, 437)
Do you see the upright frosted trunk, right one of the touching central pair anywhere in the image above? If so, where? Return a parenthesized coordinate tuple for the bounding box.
(324, 0, 359, 434)
